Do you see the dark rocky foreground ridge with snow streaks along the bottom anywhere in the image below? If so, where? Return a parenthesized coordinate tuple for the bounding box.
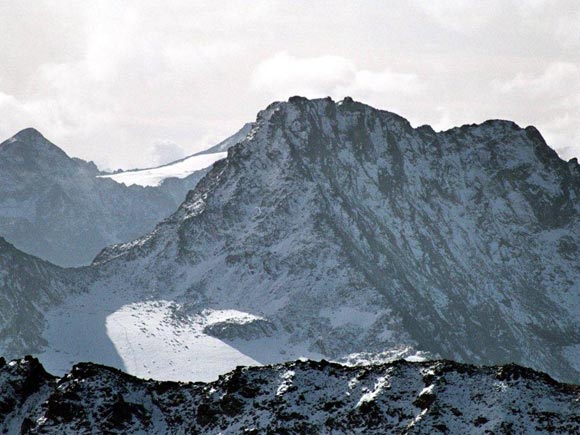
(0, 358, 580, 434)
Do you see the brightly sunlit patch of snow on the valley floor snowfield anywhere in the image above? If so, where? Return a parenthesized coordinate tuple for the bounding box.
(106, 301, 259, 381)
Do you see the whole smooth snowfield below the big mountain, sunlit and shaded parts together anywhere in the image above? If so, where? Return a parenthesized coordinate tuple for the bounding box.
(40, 294, 322, 382)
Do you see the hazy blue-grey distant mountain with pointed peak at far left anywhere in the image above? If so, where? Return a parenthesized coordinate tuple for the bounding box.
(0, 129, 247, 266)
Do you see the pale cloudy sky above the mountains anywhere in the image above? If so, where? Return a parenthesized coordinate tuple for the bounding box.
(0, 0, 580, 168)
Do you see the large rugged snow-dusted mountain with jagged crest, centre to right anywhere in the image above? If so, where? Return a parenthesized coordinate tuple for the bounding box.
(0, 98, 580, 382)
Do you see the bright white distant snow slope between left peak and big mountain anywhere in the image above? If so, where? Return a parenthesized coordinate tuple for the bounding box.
(100, 123, 252, 186)
